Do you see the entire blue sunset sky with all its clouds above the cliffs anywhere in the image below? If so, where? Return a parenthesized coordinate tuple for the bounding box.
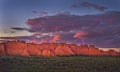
(0, 0, 120, 48)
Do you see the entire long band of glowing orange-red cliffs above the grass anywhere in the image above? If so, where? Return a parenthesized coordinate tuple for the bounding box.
(0, 41, 120, 56)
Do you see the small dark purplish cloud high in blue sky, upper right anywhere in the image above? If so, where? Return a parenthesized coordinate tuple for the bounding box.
(72, 2, 108, 11)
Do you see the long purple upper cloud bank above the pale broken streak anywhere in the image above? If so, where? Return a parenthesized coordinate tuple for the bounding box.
(27, 10, 120, 32)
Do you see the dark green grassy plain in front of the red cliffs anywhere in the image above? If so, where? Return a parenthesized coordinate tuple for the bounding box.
(0, 56, 120, 72)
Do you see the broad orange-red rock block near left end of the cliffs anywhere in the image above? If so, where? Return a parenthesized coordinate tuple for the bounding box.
(4, 41, 28, 55)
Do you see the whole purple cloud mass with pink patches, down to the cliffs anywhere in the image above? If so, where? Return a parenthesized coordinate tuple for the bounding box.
(15, 11, 120, 47)
